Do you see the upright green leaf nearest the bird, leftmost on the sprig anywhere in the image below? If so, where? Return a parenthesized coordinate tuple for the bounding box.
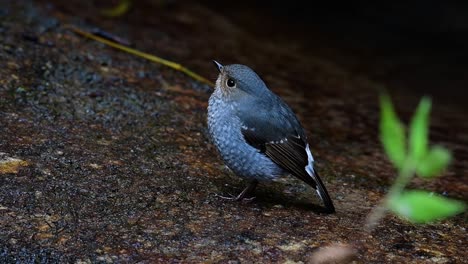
(380, 95, 406, 169)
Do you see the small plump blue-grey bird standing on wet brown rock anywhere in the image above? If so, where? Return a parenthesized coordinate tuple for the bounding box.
(207, 60, 335, 213)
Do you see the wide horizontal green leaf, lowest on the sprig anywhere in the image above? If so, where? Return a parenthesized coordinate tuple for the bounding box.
(388, 190, 465, 224)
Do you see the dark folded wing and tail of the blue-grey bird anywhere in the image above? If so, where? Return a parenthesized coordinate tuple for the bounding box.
(241, 95, 335, 212)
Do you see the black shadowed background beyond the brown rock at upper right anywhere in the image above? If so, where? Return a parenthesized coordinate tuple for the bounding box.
(201, 1, 468, 106)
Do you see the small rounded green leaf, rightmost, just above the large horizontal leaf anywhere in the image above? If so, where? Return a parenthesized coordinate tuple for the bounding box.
(416, 146, 452, 178)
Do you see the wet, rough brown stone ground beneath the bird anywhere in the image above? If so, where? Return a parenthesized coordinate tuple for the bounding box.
(0, 0, 468, 263)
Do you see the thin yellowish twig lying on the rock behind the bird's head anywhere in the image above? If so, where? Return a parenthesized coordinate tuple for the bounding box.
(65, 25, 214, 87)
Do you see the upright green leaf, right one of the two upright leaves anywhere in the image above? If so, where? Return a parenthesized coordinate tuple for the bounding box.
(408, 97, 431, 164)
